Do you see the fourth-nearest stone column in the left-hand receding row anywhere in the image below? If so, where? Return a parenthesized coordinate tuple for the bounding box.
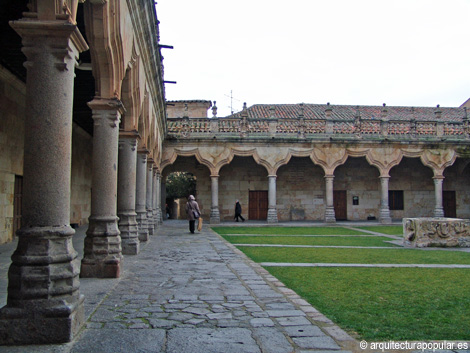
(135, 151, 149, 241)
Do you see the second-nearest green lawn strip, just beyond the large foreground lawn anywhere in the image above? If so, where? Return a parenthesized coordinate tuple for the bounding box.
(238, 246, 470, 264)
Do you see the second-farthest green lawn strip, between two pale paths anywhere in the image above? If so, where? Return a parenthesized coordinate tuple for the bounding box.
(223, 235, 396, 247)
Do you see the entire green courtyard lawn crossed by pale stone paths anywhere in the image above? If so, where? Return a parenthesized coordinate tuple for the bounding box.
(213, 226, 470, 341)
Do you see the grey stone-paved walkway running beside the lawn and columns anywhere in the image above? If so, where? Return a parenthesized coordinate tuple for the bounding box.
(0, 221, 357, 353)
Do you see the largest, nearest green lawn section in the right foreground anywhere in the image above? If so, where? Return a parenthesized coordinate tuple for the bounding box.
(267, 267, 470, 341)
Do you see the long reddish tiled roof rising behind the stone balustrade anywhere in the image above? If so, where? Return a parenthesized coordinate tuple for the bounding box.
(230, 104, 466, 122)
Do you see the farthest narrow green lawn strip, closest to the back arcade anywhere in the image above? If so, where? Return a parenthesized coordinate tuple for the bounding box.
(212, 227, 368, 235)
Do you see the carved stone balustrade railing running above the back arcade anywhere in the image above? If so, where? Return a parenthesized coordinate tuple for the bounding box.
(167, 118, 470, 141)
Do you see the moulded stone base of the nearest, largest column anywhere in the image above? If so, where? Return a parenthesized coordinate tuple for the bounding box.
(0, 226, 85, 345)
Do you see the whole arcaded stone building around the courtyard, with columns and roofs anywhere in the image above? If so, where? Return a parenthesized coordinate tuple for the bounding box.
(0, 0, 470, 344)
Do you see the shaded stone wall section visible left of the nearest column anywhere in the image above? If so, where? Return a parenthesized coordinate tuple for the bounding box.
(0, 66, 26, 243)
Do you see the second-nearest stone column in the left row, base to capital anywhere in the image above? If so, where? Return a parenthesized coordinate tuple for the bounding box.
(80, 97, 123, 278)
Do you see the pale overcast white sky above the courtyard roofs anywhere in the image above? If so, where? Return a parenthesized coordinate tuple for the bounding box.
(156, 0, 470, 116)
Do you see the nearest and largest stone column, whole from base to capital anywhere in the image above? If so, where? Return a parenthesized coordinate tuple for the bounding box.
(0, 14, 87, 345)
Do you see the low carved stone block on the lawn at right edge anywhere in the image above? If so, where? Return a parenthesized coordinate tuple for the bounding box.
(403, 218, 470, 248)
